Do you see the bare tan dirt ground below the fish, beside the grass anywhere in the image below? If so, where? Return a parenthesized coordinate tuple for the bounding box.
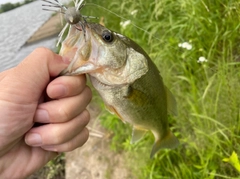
(65, 104, 134, 179)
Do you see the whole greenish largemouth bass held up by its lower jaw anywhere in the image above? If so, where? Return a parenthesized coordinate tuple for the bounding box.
(60, 23, 179, 157)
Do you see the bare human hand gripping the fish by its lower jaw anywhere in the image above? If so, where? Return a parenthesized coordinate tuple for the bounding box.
(0, 48, 91, 178)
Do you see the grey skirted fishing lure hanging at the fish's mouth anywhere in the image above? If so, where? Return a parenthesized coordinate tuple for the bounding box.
(42, 0, 96, 46)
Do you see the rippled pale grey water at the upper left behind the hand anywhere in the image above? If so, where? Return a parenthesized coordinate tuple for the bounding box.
(0, 1, 56, 72)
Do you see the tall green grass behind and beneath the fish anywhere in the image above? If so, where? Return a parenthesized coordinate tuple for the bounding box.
(81, 0, 240, 179)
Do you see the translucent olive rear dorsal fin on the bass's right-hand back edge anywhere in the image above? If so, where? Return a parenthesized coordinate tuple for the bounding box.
(165, 86, 178, 116)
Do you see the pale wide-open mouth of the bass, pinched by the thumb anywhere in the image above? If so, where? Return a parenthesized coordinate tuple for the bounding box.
(59, 25, 100, 76)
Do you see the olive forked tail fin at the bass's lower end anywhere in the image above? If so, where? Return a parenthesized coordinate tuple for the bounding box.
(150, 130, 179, 158)
